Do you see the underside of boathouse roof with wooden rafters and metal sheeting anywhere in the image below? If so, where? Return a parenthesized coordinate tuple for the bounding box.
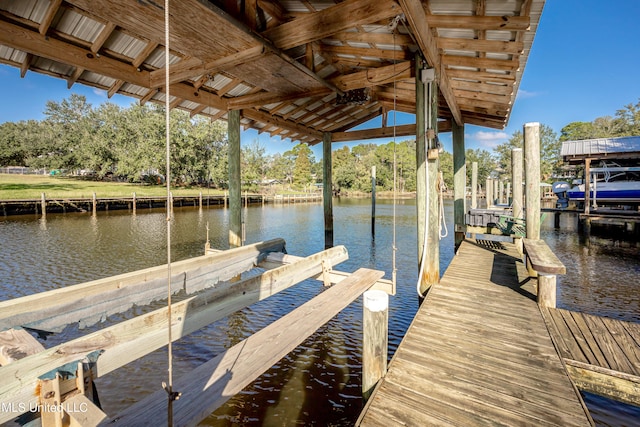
(0, 0, 544, 144)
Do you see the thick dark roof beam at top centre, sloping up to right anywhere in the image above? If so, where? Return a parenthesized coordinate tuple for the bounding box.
(262, 0, 401, 50)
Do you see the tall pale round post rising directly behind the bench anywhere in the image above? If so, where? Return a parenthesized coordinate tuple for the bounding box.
(523, 123, 540, 239)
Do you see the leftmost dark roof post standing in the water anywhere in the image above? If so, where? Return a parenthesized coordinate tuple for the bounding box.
(227, 110, 242, 248)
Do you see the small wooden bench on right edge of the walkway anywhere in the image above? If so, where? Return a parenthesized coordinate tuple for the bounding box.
(522, 239, 567, 308)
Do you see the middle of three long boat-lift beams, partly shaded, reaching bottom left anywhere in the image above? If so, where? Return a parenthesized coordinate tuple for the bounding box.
(0, 246, 350, 423)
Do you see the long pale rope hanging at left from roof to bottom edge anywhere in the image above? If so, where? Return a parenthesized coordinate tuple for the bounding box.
(162, 0, 180, 427)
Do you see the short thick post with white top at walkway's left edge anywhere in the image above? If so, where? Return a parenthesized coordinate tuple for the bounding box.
(362, 290, 389, 400)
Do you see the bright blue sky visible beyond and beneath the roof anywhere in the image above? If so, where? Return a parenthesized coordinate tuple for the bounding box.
(0, 0, 640, 158)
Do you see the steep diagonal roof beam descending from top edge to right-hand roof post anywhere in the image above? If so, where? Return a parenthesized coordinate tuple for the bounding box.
(399, 0, 464, 125)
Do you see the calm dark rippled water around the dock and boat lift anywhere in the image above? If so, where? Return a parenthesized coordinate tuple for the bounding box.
(0, 199, 640, 426)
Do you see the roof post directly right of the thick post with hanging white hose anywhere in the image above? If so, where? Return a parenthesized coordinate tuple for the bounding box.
(451, 120, 467, 251)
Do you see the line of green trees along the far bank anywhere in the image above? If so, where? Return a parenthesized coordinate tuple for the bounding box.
(0, 94, 640, 192)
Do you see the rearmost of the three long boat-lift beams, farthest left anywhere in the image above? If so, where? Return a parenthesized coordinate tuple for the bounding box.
(0, 239, 285, 331)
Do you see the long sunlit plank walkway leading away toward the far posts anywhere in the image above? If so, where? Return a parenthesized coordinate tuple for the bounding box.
(358, 240, 593, 427)
